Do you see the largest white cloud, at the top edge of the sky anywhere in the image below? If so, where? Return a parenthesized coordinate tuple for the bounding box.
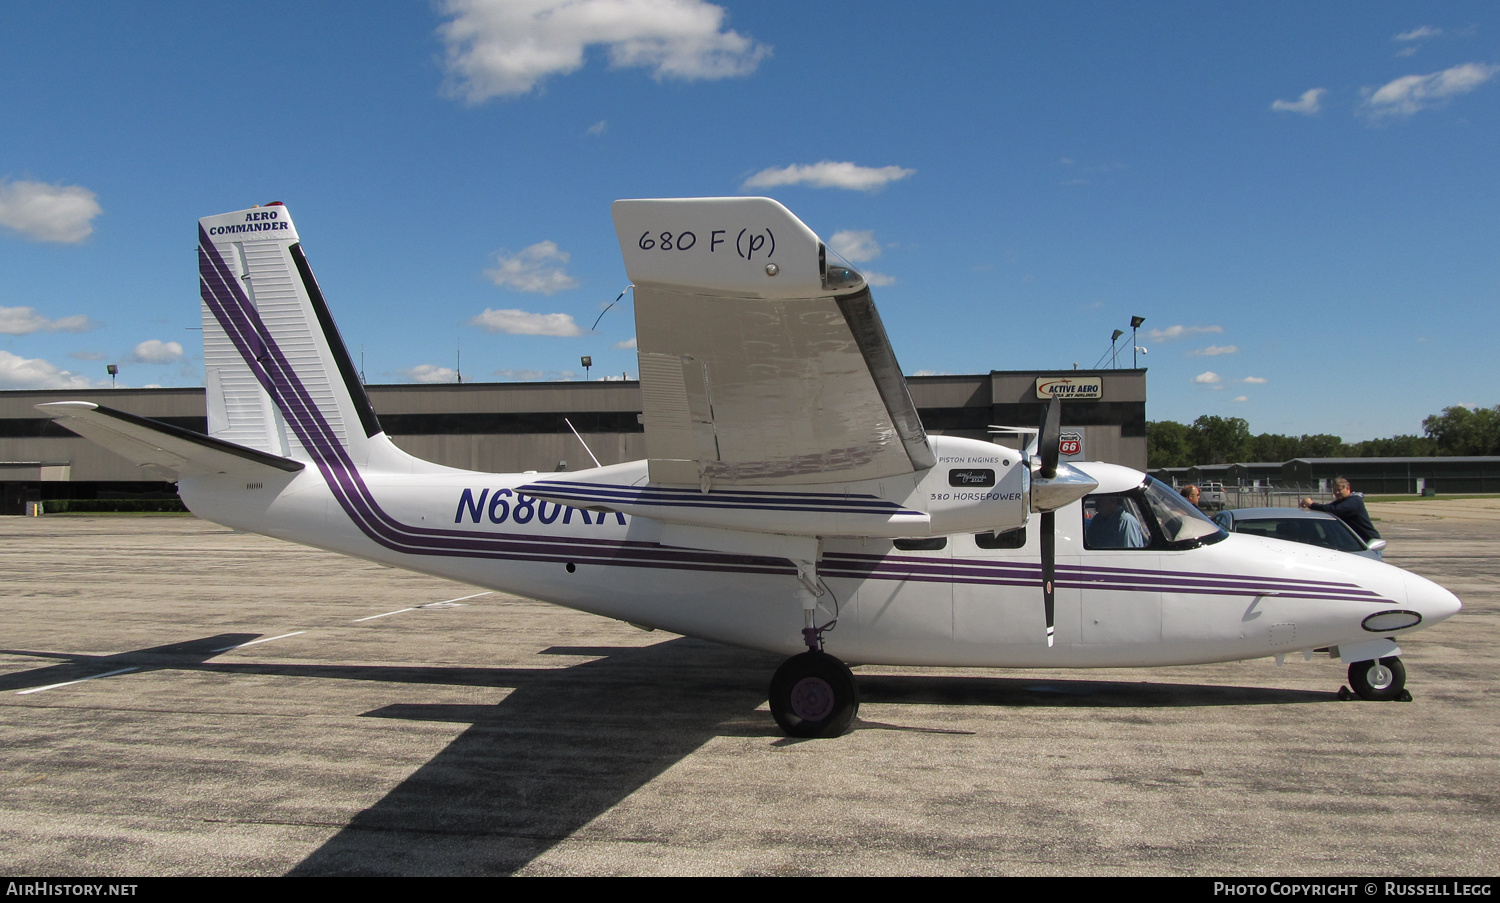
(438, 0, 771, 104)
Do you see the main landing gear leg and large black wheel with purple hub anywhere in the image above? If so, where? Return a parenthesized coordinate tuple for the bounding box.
(771, 561, 860, 737)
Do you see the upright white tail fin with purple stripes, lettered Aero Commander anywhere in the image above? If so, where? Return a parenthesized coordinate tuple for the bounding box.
(198, 203, 410, 467)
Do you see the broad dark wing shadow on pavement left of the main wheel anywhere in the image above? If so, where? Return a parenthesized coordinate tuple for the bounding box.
(282, 639, 780, 875)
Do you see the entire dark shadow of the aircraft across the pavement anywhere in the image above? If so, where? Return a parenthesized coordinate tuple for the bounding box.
(0, 633, 1334, 875)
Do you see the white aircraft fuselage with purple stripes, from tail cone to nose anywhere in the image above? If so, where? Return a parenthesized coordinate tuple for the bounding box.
(180, 462, 1458, 668)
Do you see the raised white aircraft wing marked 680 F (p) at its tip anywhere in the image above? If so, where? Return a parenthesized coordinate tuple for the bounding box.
(614, 198, 936, 489)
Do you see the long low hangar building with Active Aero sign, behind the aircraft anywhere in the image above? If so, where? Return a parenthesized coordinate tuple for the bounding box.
(0, 369, 1146, 515)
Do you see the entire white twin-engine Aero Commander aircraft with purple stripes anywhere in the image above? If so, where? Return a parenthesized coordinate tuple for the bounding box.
(39, 198, 1460, 737)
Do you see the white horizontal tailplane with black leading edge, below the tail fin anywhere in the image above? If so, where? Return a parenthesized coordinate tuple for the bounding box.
(36, 402, 303, 480)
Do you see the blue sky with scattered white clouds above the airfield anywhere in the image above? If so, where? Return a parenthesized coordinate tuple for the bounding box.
(0, 0, 1500, 441)
